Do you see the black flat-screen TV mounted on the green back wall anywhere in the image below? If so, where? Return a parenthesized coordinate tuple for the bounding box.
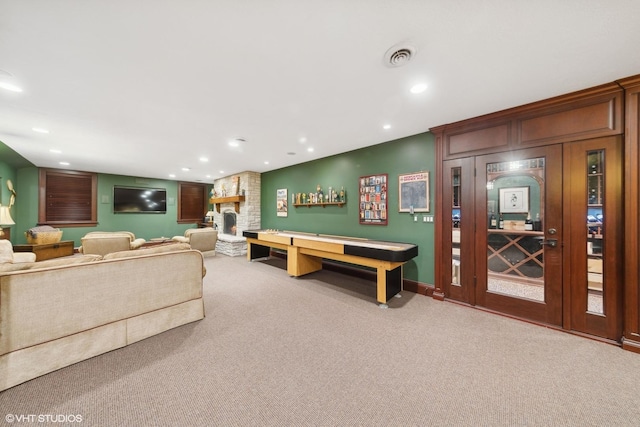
(113, 185, 167, 213)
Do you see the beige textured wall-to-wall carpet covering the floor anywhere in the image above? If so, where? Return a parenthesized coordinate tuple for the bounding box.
(0, 255, 640, 426)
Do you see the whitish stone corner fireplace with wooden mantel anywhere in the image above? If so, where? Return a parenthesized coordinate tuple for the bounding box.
(211, 172, 260, 256)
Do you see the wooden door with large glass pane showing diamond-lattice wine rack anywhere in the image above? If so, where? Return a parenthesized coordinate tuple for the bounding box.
(475, 146, 562, 325)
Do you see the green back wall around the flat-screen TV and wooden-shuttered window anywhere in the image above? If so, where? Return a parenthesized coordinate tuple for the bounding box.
(15, 168, 196, 246)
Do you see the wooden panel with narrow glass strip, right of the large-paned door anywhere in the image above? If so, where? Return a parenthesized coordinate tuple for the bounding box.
(564, 136, 623, 340)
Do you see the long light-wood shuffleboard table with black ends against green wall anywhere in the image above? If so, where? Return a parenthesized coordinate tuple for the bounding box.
(242, 230, 418, 308)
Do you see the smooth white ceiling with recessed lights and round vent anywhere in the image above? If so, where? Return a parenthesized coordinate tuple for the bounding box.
(0, 0, 640, 182)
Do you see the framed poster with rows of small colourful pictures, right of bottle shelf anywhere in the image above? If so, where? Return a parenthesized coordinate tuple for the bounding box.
(358, 174, 388, 225)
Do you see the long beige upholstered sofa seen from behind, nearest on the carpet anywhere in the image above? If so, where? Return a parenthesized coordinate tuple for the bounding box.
(0, 244, 205, 391)
